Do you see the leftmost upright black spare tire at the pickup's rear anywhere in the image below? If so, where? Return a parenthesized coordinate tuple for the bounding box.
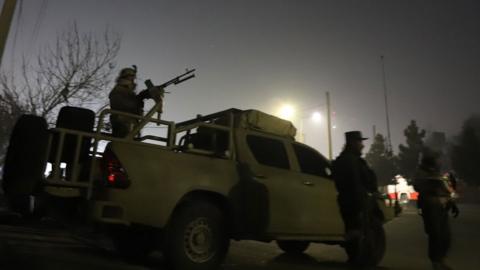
(2, 115, 48, 215)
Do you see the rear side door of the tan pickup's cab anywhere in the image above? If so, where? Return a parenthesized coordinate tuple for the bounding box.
(237, 133, 303, 234)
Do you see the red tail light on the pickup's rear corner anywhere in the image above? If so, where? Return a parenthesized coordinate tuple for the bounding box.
(102, 148, 130, 188)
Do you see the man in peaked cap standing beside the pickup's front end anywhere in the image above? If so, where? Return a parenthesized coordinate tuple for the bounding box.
(333, 131, 377, 260)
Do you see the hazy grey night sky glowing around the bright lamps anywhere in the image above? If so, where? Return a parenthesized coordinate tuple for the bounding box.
(0, 0, 480, 154)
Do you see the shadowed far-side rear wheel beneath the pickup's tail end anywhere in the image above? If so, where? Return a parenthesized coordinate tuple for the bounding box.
(109, 225, 155, 261)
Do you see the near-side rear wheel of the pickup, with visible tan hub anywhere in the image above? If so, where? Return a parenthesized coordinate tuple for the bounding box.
(164, 201, 230, 270)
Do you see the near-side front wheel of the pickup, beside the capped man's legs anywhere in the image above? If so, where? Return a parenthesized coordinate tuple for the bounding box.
(345, 220, 386, 267)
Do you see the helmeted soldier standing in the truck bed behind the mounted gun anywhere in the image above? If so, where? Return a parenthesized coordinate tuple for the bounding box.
(108, 66, 150, 138)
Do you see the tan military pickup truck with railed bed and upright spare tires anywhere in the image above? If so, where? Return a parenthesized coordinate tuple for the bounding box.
(3, 96, 393, 270)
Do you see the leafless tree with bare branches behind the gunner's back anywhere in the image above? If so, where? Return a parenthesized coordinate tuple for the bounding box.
(0, 23, 120, 160)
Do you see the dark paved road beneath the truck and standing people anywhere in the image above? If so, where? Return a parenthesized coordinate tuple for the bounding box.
(0, 205, 480, 270)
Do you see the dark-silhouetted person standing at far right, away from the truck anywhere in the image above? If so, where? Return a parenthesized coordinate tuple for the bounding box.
(414, 149, 459, 270)
